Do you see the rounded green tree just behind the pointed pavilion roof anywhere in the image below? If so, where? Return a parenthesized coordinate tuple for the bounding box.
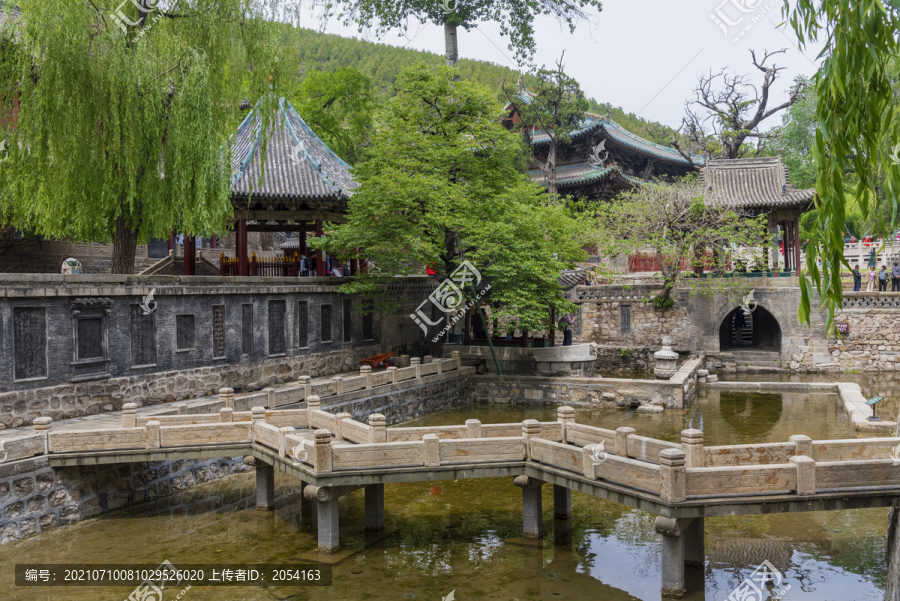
(294, 67, 375, 165)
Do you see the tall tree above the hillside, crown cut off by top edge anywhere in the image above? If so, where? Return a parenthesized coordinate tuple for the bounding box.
(326, 0, 602, 66)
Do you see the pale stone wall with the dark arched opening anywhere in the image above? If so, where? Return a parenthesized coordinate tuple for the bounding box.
(569, 278, 900, 376)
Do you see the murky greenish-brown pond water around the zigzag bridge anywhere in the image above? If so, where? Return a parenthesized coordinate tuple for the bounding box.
(0, 389, 887, 601)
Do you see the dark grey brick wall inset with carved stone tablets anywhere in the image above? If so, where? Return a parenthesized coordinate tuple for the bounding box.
(0, 274, 430, 430)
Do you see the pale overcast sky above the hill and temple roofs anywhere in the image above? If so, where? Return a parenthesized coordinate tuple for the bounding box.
(306, 0, 819, 129)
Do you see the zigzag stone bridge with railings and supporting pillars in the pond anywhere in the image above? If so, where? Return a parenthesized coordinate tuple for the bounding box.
(0, 376, 900, 596)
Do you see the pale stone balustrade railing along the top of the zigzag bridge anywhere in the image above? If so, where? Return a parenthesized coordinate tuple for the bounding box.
(0, 404, 900, 503)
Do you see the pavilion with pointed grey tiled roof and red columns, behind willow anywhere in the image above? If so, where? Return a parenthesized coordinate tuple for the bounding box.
(216, 98, 358, 276)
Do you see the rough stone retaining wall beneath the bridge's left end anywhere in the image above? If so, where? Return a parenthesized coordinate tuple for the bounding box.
(0, 457, 252, 544)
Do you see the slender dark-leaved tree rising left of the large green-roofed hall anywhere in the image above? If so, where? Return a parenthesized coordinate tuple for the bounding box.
(506, 57, 588, 201)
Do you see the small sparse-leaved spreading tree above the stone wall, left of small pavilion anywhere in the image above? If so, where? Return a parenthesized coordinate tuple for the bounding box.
(591, 178, 766, 298)
